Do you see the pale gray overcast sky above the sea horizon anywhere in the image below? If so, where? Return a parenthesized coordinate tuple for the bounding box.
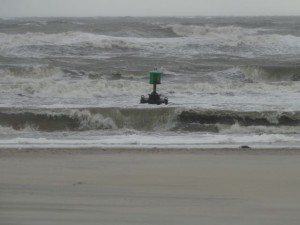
(0, 0, 300, 17)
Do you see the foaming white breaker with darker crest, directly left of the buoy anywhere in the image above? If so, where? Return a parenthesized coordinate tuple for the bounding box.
(0, 65, 147, 98)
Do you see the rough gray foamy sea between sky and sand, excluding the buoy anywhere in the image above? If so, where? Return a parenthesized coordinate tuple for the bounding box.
(0, 17, 300, 148)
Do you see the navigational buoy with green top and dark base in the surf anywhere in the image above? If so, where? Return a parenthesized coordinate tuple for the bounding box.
(141, 68, 168, 105)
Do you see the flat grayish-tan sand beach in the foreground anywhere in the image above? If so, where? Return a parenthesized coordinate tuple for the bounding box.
(0, 149, 300, 225)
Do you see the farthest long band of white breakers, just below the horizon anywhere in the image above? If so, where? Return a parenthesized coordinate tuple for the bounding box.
(0, 24, 300, 58)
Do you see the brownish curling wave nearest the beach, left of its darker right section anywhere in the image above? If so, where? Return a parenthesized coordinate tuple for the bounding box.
(0, 108, 176, 132)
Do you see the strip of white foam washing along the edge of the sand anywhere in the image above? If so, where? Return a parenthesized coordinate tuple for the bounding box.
(0, 133, 300, 148)
